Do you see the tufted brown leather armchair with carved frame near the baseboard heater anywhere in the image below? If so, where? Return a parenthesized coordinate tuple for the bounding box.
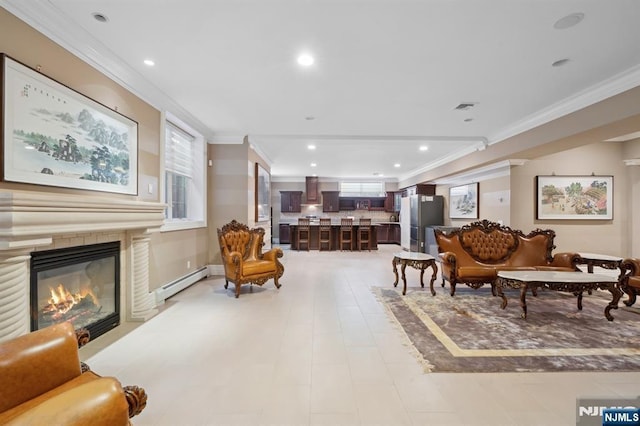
(218, 220, 284, 298)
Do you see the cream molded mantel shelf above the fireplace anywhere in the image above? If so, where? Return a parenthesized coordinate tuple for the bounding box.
(0, 191, 165, 250)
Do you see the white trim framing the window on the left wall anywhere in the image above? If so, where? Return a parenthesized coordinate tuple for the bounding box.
(158, 111, 208, 232)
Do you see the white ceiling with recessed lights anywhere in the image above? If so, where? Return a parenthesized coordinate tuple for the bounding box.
(5, 0, 640, 179)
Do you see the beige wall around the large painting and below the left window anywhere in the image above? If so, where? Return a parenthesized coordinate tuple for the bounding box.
(0, 8, 207, 290)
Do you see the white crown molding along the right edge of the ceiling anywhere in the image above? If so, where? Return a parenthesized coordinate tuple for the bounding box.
(488, 61, 640, 145)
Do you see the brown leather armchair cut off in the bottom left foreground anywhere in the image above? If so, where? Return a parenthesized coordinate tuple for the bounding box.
(0, 322, 147, 426)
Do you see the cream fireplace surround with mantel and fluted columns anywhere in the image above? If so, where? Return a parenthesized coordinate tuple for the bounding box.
(0, 190, 165, 342)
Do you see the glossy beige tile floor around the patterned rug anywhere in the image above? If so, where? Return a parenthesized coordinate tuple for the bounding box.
(81, 245, 640, 426)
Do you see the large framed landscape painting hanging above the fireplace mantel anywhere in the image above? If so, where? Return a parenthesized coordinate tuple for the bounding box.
(1, 55, 138, 195)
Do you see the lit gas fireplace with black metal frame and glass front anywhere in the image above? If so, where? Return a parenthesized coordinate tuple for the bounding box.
(30, 241, 120, 339)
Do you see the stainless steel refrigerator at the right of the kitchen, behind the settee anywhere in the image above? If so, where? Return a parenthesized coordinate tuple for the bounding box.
(409, 195, 444, 253)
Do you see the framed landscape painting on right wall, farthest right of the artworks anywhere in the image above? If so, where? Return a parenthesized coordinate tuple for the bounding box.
(536, 176, 613, 220)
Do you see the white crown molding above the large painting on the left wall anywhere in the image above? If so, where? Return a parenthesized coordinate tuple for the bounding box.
(2, 0, 215, 140)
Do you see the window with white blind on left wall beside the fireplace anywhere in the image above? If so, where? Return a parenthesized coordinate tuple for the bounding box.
(163, 115, 206, 230)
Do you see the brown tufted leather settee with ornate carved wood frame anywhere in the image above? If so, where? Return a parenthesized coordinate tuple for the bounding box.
(434, 220, 580, 296)
